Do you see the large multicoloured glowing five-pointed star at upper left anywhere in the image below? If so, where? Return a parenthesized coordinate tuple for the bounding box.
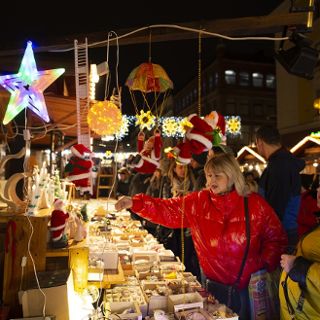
(0, 41, 65, 125)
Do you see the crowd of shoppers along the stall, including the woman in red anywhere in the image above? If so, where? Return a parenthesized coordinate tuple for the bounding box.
(112, 126, 320, 320)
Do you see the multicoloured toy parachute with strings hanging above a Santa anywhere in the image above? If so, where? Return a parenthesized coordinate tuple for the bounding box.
(126, 62, 173, 130)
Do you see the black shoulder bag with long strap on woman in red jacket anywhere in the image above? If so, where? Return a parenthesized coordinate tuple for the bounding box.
(206, 197, 250, 313)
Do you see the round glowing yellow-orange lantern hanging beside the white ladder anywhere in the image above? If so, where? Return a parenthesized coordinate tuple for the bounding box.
(88, 100, 122, 136)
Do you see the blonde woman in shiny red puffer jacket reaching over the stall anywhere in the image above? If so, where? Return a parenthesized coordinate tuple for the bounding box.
(116, 154, 287, 320)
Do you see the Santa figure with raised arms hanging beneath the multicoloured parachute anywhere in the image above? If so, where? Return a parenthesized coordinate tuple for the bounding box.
(128, 129, 162, 174)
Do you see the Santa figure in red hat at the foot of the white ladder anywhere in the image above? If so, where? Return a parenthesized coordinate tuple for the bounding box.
(65, 143, 93, 195)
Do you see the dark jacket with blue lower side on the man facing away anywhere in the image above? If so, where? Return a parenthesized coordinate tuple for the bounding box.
(259, 148, 305, 230)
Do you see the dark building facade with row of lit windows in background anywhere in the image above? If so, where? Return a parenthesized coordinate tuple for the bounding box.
(174, 46, 277, 152)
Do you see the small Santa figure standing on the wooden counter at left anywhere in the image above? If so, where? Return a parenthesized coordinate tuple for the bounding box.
(50, 199, 69, 248)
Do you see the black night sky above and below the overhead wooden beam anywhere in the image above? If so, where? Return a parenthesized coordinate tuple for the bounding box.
(0, 0, 282, 113)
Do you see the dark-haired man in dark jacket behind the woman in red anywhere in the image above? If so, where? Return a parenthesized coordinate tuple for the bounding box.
(256, 126, 305, 249)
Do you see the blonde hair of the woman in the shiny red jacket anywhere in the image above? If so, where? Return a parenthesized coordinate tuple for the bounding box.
(204, 153, 250, 196)
